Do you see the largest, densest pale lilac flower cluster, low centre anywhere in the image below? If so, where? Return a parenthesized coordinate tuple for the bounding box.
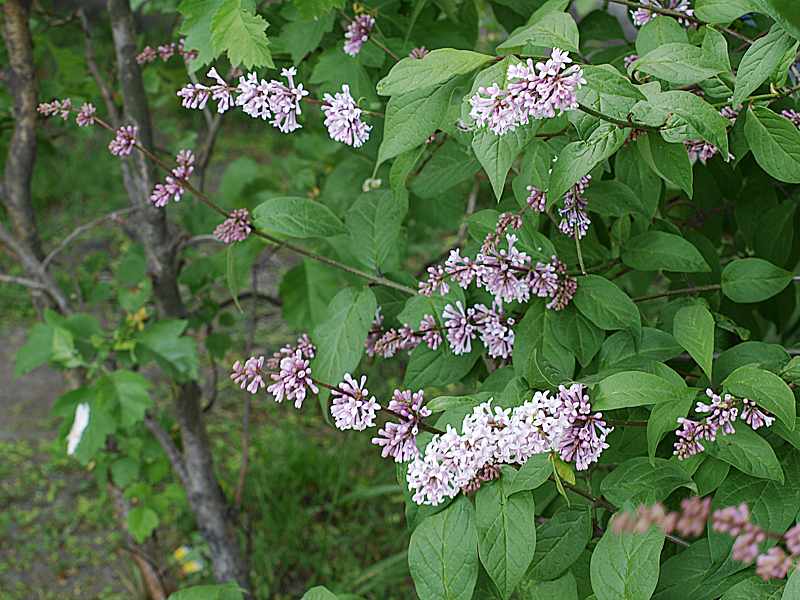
(407, 384, 611, 506)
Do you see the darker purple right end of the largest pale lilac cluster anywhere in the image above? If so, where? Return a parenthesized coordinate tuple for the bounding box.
(558, 383, 614, 471)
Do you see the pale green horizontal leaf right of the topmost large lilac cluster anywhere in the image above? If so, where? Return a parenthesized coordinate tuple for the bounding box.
(631, 43, 724, 85)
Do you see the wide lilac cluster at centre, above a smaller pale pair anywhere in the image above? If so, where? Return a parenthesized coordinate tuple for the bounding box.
(419, 234, 578, 310)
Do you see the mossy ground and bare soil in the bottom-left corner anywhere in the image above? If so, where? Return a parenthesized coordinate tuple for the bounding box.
(0, 328, 131, 600)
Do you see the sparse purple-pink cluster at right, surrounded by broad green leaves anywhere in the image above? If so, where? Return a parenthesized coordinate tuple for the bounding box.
(674, 388, 775, 460)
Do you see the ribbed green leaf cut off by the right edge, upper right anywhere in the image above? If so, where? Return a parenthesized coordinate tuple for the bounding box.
(744, 106, 800, 183)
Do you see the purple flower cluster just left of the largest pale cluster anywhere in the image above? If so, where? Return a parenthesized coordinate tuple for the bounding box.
(372, 390, 431, 462)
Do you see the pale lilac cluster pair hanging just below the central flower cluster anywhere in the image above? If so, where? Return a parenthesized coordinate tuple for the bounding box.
(442, 301, 514, 358)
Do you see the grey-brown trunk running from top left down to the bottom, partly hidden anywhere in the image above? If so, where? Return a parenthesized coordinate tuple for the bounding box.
(108, 0, 250, 590)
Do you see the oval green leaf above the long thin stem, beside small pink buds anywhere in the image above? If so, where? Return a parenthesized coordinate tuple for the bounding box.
(253, 196, 347, 238)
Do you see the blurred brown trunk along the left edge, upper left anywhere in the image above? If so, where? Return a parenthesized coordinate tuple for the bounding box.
(2, 0, 44, 260)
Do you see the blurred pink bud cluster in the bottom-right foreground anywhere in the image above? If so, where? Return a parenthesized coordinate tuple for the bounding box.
(612, 497, 800, 581)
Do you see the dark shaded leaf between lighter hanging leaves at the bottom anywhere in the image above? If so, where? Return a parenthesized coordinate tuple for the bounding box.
(528, 506, 592, 580)
